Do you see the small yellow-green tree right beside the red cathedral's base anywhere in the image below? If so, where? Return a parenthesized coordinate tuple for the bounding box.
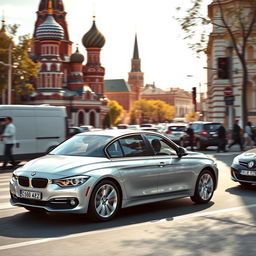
(104, 100, 124, 127)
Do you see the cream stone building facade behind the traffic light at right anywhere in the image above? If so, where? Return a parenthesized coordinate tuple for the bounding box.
(206, 0, 256, 128)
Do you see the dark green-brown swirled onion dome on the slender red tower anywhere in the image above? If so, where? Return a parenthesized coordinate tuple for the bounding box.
(82, 20, 105, 48)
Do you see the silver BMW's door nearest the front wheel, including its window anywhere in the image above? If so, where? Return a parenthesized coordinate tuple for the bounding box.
(107, 135, 158, 200)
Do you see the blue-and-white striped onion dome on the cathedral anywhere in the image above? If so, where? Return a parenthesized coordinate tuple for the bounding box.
(36, 15, 64, 40)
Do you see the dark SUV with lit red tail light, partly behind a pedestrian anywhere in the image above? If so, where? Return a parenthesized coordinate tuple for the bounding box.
(179, 122, 220, 149)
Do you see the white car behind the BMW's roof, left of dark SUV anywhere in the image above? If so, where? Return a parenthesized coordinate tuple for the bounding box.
(163, 123, 188, 144)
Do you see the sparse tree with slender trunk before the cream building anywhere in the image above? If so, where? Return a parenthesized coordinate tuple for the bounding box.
(178, 0, 256, 125)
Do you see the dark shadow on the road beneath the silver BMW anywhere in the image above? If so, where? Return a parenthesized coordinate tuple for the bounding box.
(0, 198, 213, 238)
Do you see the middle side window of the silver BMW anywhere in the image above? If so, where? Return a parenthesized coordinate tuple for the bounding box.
(119, 135, 151, 157)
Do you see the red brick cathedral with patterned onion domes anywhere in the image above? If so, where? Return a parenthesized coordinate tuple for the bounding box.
(26, 0, 108, 127)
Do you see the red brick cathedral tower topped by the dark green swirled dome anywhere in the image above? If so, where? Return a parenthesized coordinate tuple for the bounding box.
(82, 16, 105, 97)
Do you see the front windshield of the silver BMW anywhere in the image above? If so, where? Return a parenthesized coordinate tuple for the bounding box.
(50, 135, 112, 157)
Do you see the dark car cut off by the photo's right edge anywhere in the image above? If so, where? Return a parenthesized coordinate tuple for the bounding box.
(231, 148, 256, 186)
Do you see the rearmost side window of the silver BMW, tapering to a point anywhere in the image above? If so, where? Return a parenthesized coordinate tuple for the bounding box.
(145, 134, 176, 155)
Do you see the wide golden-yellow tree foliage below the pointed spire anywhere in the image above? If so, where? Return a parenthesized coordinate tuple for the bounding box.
(130, 99, 175, 123)
